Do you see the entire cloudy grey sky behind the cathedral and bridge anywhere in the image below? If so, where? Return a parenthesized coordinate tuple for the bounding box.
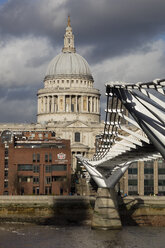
(0, 0, 165, 122)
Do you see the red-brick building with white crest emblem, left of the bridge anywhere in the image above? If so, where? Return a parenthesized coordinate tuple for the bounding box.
(0, 130, 71, 195)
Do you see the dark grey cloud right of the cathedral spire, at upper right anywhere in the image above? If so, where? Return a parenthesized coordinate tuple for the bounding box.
(68, 0, 165, 63)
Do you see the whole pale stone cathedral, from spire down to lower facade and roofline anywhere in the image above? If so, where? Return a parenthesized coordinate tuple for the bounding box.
(0, 17, 104, 171)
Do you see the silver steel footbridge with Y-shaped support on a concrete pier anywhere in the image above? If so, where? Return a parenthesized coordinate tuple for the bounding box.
(77, 79, 165, 228)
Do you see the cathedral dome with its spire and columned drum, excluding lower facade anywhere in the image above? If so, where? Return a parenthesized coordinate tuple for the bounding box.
(38, 17, 100, 126)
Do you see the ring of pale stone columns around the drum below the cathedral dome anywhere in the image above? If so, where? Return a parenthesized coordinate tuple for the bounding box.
(38, 95, 100, 114)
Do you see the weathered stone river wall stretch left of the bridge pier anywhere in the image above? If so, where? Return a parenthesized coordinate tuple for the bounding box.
(0, 196, 95, 225)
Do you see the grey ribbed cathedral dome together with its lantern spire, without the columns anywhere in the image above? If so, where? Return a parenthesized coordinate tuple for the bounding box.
(45, 17, 93, 81)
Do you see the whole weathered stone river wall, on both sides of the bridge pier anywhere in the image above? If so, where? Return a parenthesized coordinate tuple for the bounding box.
(0, 196, 165, 226)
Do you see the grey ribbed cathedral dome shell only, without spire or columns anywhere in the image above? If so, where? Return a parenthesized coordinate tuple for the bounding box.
(45, 52, 93, 80)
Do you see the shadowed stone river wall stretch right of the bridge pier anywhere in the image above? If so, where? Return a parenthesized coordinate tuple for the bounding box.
(119, 196, 165, 226)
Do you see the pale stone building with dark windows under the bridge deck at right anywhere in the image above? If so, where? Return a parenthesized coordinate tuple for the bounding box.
(120, 159, 165, 195)
